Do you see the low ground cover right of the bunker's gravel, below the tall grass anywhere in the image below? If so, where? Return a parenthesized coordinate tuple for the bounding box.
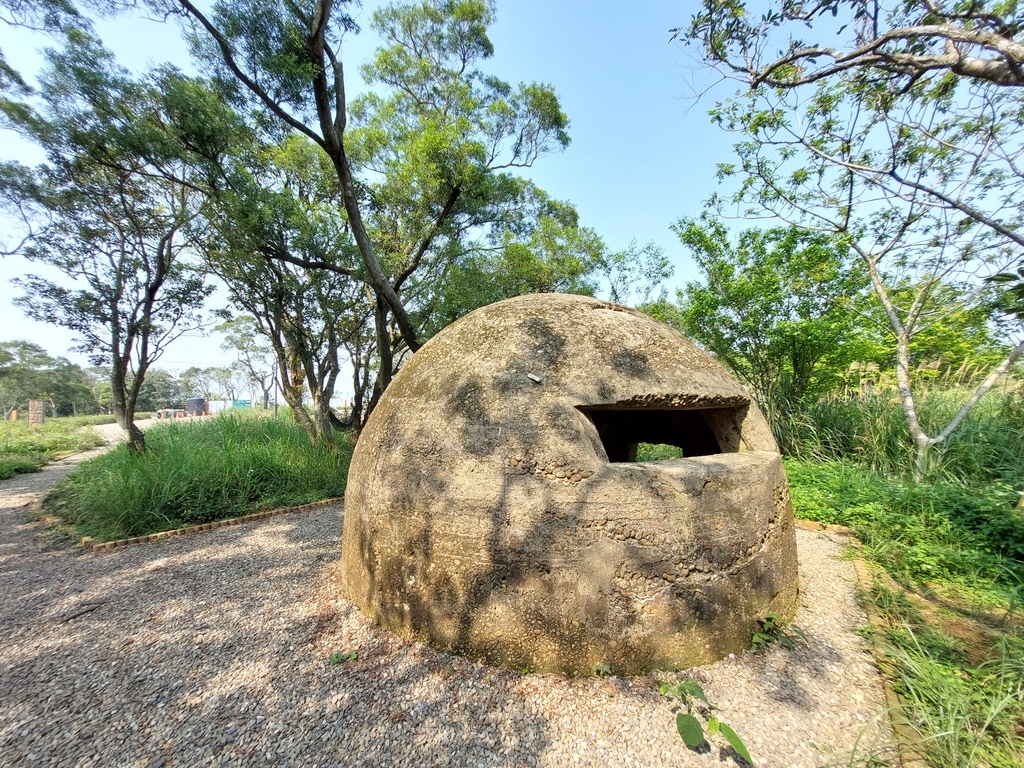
(786, 460, 1024, 768)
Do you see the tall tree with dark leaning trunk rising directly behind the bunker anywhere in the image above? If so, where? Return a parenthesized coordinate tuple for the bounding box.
(155, 2, 604, 428)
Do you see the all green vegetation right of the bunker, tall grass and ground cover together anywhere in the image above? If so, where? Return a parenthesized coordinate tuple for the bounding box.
(786, 391, 1024, 768)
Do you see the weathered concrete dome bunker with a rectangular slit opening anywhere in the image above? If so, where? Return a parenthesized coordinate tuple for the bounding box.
(342, 294, 798, 674)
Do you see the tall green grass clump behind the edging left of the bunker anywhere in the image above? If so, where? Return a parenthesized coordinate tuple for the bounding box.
(43, 415, 352, 540)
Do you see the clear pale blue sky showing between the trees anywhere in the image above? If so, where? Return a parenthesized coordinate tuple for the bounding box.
(0, 0, 735, 382)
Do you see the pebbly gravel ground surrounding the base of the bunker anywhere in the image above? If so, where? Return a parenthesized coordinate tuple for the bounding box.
(0, 450, 891, 768)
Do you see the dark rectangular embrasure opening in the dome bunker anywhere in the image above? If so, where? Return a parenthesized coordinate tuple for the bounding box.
(580, 406, 739, 463)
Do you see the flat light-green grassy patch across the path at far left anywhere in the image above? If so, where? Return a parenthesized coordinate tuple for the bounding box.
(0, 416, 114, 479)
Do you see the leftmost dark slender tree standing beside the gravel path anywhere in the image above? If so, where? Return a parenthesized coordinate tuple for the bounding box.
(5, 31, 211, 453)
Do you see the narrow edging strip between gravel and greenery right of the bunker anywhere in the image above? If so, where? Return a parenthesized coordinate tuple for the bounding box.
(796, 520, 928, 768)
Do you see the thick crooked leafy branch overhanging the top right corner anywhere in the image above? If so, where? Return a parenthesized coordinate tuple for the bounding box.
(673, 0, 1024, 89)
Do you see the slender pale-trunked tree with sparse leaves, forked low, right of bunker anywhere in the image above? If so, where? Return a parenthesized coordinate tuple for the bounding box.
(687, 0, 1024, 475)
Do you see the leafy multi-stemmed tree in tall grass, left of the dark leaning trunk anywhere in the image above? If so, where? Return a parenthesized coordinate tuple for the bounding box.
(194, 134, 372, 442)
